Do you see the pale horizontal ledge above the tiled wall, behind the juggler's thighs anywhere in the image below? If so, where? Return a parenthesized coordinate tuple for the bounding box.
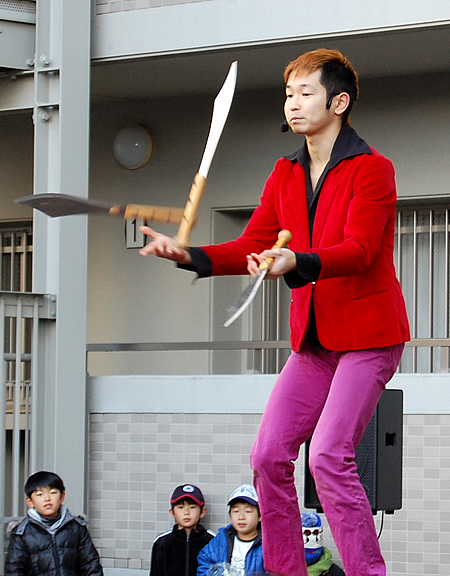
(87, 374, 450, 414)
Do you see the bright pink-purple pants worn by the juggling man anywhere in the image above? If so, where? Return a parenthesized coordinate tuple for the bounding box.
(250, 344, 404, 576)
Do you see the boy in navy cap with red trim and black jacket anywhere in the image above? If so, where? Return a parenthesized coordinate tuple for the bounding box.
(150, 484, 214, 576)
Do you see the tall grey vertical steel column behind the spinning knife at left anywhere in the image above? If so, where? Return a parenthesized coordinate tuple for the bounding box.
(31, 0, 91, 513)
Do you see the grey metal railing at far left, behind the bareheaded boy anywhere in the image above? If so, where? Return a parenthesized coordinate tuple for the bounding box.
(0, 292, 56, 568)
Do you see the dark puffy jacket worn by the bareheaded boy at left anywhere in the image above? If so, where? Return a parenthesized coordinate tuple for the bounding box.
(5, 510, 103, 576)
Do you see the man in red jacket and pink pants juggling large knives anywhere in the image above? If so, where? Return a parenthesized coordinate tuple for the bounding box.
(141, 49, 409, 576)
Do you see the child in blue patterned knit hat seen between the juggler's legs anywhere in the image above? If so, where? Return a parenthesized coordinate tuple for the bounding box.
(302, 512, 345, 576)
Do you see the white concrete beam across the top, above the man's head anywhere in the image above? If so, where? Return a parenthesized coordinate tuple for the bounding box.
(92, 0, 450, 59)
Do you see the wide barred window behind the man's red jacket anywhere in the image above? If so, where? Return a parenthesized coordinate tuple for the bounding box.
(211, 199, 450, 374)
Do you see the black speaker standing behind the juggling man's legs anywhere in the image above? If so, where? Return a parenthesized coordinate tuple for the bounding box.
(304, 390, 403, 514)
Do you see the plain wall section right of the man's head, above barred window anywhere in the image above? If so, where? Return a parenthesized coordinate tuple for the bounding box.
(354, 74, 450, 196)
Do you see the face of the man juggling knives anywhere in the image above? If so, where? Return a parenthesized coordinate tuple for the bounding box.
(284, 70, 338, 136)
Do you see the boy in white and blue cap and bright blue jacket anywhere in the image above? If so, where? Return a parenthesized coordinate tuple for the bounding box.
(197, 484, 268, 576)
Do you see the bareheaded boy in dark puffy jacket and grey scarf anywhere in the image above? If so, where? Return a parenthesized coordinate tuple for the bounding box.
(5, 471, 103, 576)
